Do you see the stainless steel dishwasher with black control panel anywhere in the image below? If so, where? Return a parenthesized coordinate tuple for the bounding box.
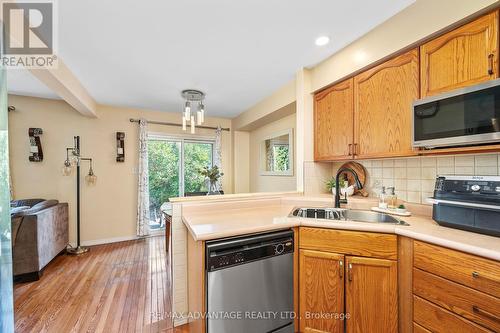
(206, 230, 294, 333)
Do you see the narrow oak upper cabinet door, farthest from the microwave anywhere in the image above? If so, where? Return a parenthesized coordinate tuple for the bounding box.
(314, 78, 354, 161)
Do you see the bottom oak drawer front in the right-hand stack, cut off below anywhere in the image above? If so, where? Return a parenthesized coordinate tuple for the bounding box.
(413, 296, 492, 333)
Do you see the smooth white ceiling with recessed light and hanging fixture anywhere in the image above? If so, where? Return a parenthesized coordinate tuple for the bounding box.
(8, 0, 414, 117)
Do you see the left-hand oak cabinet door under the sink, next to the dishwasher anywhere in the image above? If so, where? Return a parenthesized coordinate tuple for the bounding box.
(299, 250, 344, 333)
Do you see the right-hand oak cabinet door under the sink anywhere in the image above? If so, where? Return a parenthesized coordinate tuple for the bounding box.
(346, 257, 398, 333)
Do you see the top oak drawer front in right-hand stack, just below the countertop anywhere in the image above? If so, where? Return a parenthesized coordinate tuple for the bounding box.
(413, 241, 500, 297)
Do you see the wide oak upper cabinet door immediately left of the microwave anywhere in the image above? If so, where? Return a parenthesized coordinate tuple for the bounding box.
(354, 49, 419, 158)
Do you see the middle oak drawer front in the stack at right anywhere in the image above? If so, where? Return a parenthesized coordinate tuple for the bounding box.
(413, 269, 500, 332)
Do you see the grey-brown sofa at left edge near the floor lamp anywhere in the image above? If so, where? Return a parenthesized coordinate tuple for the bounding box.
(11, 199, 68, 282)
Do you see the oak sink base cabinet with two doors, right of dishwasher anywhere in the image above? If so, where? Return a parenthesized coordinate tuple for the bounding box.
(299, 227, 398, 333)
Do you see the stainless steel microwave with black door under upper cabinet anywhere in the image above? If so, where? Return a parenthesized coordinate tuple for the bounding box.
(412, 79, 500, 148)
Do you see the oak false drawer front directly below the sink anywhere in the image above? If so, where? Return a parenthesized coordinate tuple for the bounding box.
(299, 227, 398, 260)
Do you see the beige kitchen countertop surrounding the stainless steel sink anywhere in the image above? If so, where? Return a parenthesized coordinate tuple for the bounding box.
(182, 196, 500, 261)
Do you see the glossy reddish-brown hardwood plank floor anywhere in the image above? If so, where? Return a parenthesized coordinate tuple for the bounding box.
(14, 236, 189, 333)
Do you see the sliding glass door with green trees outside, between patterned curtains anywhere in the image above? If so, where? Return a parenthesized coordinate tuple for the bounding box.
(148, 136, 214, 230)
